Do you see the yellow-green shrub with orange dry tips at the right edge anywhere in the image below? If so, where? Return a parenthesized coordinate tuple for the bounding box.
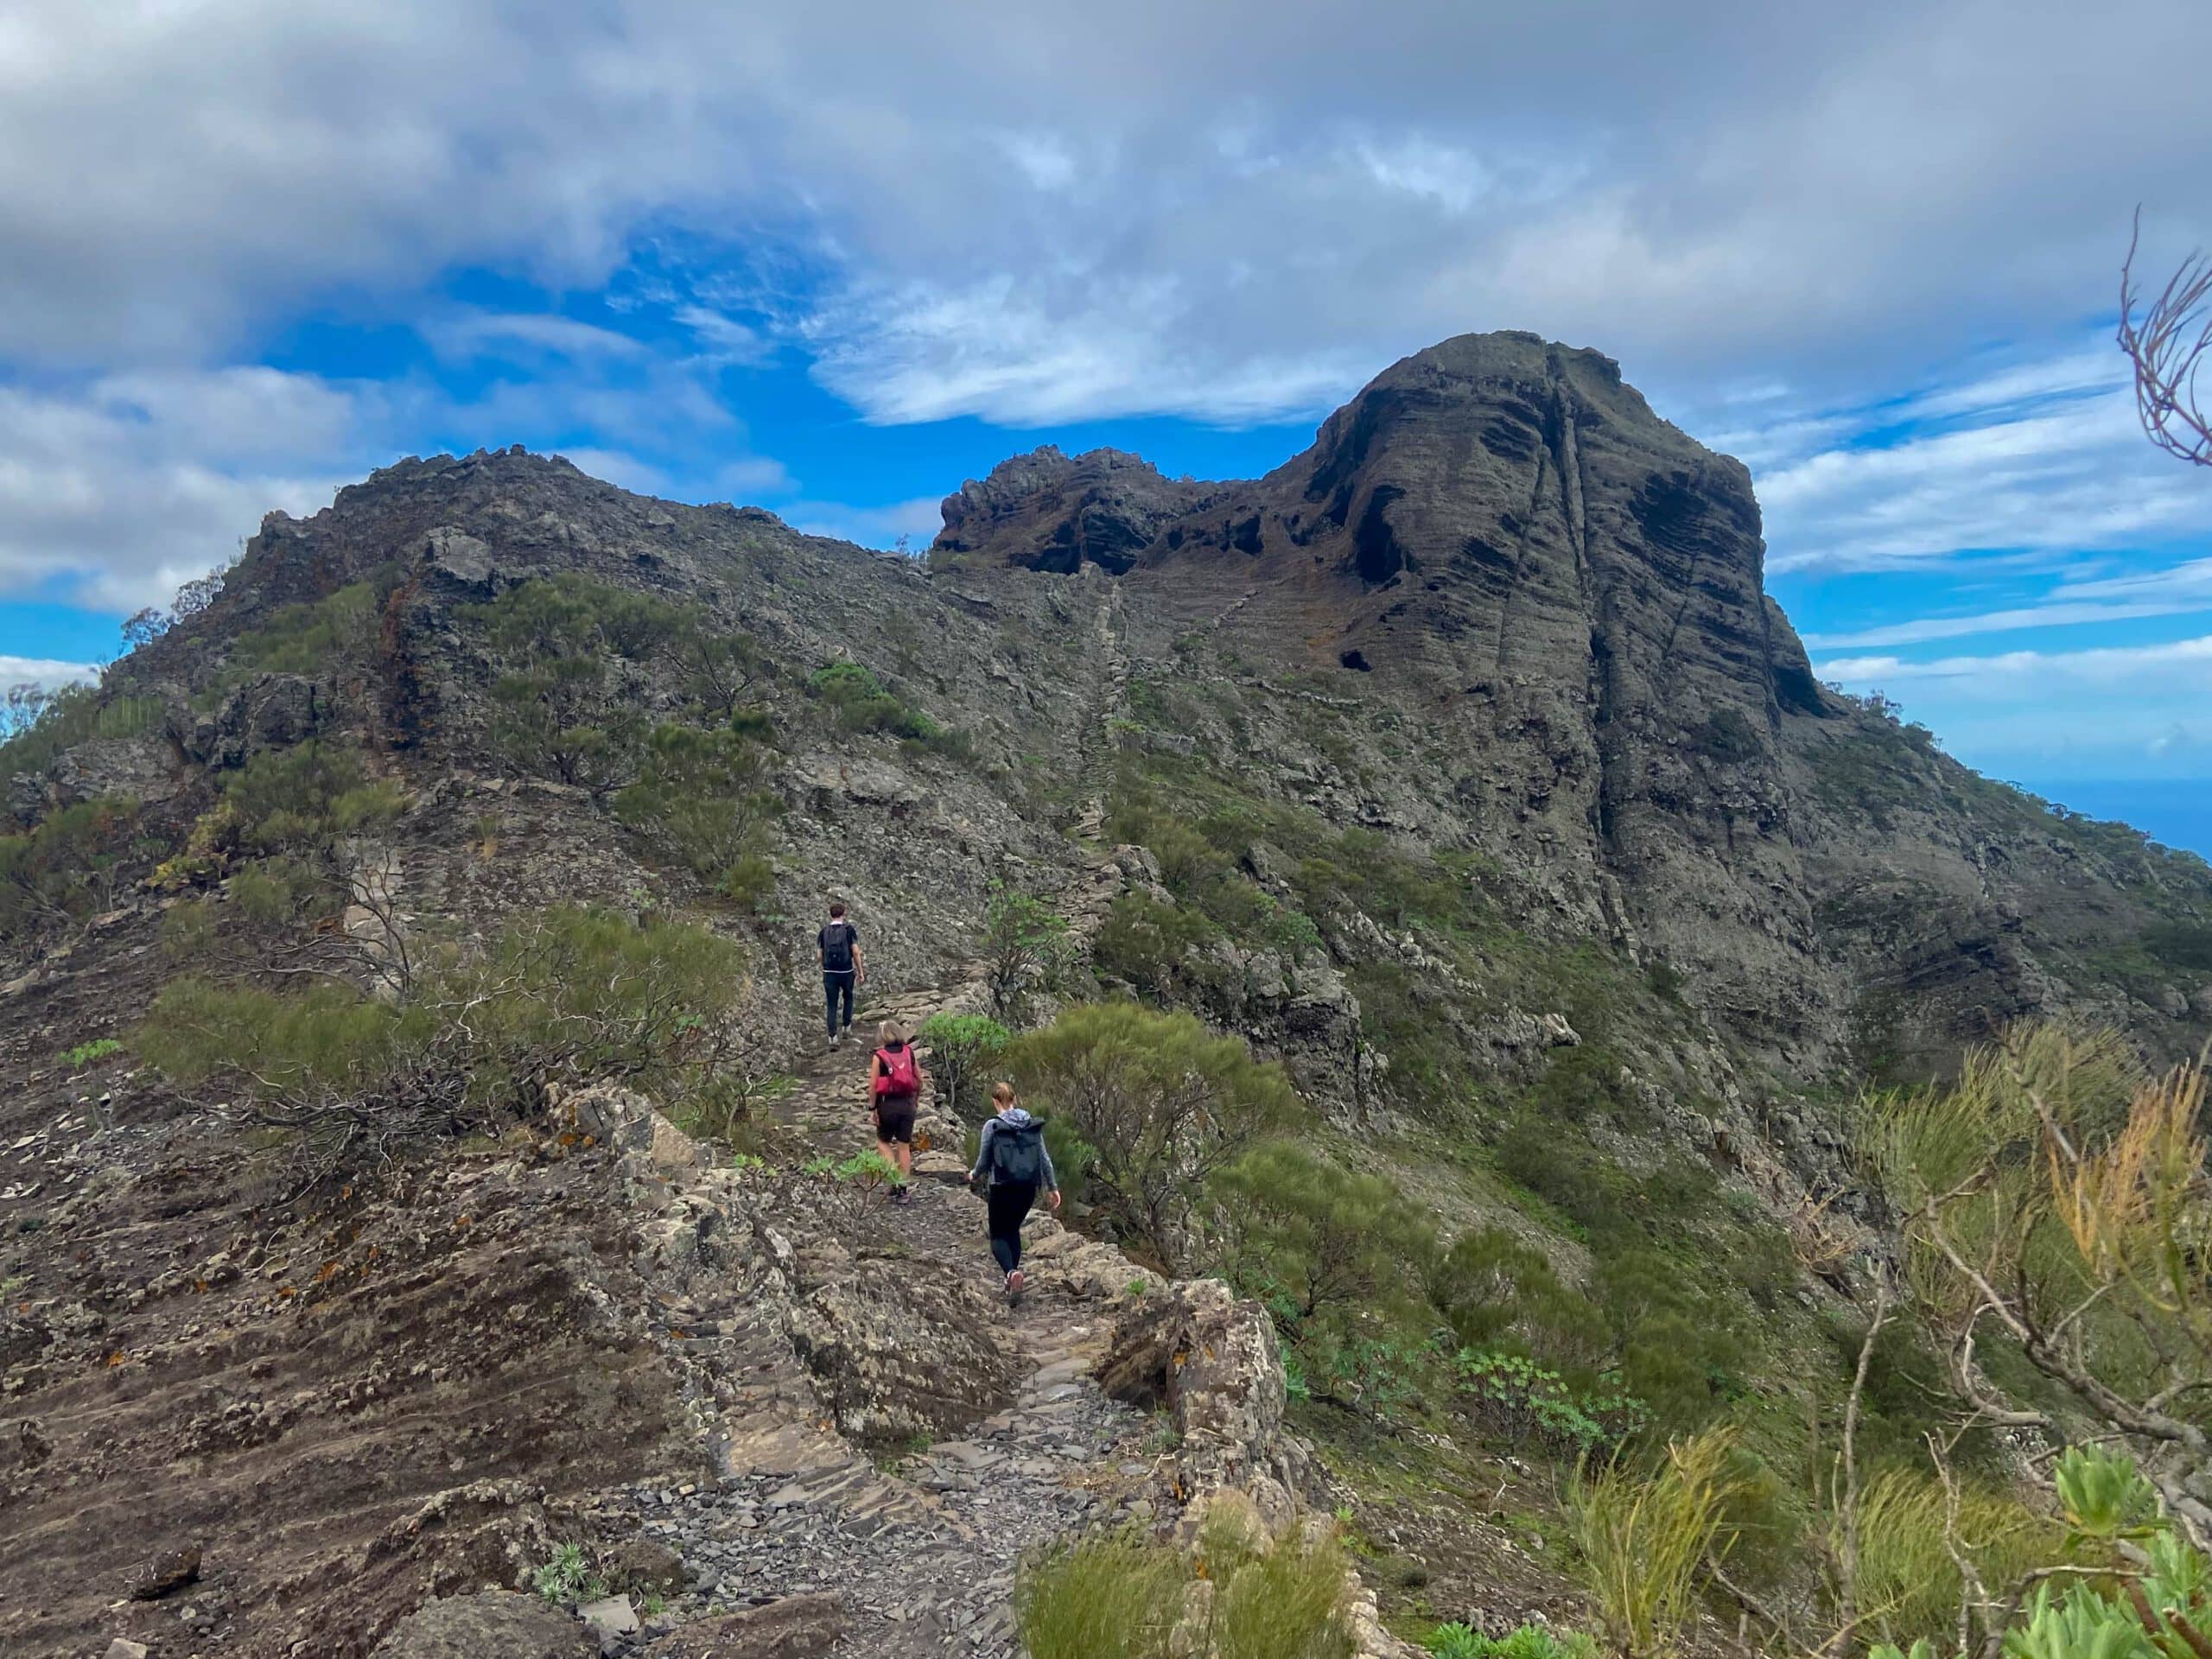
(1869, 1027, 2212, 1548)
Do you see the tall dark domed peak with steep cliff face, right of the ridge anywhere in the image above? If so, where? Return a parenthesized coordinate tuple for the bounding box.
(940, 334, 2212, 1075)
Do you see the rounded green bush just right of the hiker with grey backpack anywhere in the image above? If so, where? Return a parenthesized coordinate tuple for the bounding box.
(1007, 1002, 1299, 1272)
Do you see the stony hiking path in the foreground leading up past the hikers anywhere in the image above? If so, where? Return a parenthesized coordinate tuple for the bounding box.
(601, 976, 1174, 1659)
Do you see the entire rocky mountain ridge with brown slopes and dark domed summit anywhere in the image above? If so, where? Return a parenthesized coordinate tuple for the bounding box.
(0, 334, 2212, 1659)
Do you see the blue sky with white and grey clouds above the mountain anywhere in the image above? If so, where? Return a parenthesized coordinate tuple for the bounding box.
(0, 0, 2212, 852)
